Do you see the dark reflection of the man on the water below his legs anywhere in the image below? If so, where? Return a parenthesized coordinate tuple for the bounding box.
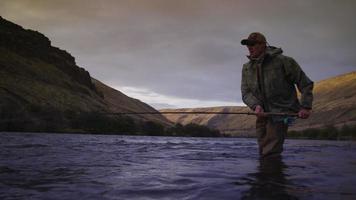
(241, 156, 298, 200)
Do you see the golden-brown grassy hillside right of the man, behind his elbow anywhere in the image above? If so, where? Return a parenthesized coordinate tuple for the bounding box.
(293, 72, 356, 130)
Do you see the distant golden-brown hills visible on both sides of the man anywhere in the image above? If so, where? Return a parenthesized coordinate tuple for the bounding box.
(160, 72, 356, 136)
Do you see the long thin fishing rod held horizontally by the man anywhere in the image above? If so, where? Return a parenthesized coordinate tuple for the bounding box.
(100, 111, 298, 117)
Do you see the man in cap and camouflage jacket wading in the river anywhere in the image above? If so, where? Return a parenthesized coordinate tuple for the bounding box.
(241, 32, 313, 157)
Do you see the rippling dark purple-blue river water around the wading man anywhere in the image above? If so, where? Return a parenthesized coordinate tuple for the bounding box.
(0, 133, 356, 200)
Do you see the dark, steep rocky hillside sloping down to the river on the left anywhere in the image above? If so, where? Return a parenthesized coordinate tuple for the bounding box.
(0, 17, 170, 131)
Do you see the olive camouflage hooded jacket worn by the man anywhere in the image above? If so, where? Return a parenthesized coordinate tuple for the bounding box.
(241, 47, 313, 112)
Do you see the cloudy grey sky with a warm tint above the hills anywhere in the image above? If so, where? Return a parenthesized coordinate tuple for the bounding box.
(0, 0, 356, 109)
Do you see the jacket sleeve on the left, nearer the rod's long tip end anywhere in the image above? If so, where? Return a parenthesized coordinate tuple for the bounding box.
(241, 67, 262, 110)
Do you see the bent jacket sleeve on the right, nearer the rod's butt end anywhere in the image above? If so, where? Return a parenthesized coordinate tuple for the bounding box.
(284, 57, 314, 109)
